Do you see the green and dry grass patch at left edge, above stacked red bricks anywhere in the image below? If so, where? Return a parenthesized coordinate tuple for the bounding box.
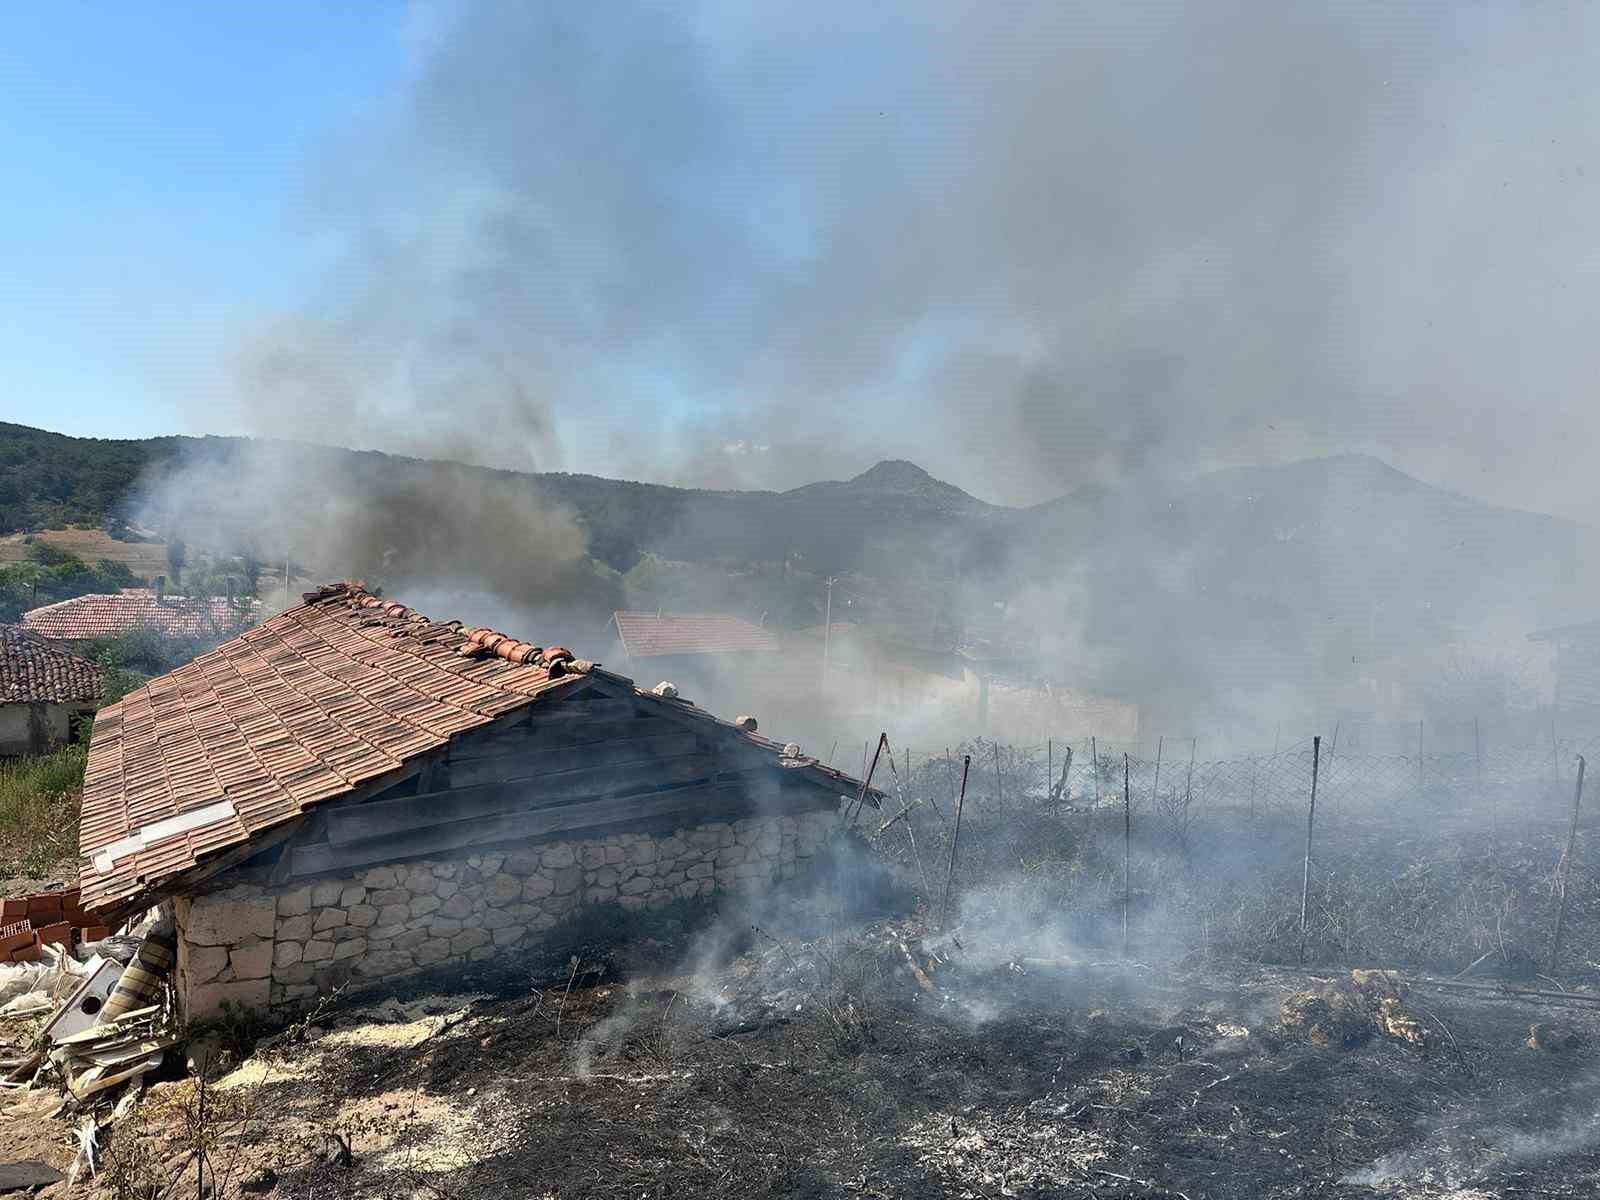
(0, 746, 88, 878)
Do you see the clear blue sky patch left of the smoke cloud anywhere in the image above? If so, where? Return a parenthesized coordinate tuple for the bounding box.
(0, 0, 406, 437)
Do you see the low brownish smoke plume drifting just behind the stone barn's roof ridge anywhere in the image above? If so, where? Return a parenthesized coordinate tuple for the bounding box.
(141, 442, 622, 646)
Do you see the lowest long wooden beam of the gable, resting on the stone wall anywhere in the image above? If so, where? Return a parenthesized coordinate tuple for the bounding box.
(293, 784, 750, 877)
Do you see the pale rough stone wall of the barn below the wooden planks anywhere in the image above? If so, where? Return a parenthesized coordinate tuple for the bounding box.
(174, 813, 837, 1018)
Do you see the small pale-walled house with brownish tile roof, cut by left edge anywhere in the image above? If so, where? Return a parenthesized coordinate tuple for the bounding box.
(0, 626, 102, 755)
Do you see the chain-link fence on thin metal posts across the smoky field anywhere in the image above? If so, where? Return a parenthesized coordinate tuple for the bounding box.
(859, 736, 1600, 965)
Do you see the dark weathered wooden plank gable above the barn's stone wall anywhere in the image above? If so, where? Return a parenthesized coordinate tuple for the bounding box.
(288, 694, 837, 877)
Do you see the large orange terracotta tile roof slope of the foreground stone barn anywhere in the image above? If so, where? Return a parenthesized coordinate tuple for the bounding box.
(78, 584, 589, 909)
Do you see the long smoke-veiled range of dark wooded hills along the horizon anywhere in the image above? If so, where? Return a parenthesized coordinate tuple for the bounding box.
(0, 426, 1600, 739)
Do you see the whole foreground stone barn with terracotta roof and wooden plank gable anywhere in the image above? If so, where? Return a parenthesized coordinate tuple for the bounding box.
(80, 584, 875, 1018)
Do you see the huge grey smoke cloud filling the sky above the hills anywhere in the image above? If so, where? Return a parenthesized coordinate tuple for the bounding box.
(200, 2, 1595, 515)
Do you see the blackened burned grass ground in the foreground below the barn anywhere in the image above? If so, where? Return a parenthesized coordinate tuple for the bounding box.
(68, 922, 1600, 1200)
